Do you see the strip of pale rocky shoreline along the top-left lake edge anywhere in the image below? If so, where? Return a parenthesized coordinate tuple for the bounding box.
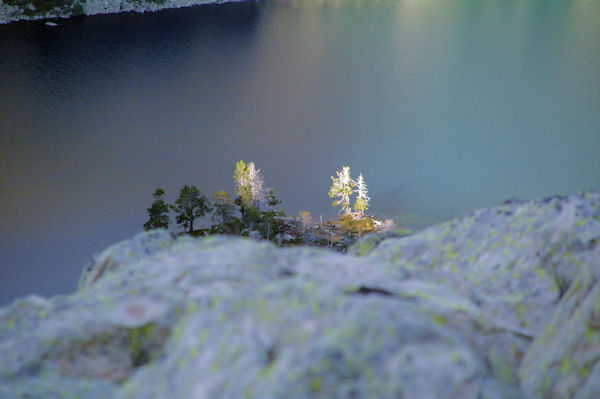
(0, 0, 245, 24)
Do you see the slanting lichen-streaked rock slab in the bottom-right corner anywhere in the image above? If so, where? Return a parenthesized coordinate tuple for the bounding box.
(519, 244, 600, 399)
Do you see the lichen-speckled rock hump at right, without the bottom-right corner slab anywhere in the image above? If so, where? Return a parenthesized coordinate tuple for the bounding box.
(369, 193, 600, 336)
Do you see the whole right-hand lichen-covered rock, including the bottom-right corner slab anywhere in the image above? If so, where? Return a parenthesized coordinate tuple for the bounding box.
(369, 193, 600, 399)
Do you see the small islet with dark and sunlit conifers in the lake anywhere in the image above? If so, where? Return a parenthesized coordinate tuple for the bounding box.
(143, 160, 410, 252)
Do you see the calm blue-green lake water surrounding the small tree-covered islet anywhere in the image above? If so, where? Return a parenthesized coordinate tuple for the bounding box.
(0, 0, 600, 303)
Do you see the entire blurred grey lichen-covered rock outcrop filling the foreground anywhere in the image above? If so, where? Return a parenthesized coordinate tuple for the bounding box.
(0, 193, 600, 399)
